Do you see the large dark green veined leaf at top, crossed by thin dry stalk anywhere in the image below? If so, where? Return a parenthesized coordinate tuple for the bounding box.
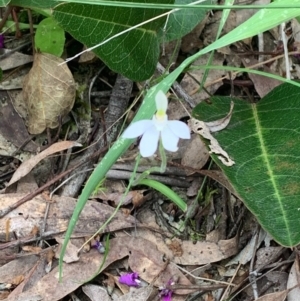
(53, 0, 172, 81)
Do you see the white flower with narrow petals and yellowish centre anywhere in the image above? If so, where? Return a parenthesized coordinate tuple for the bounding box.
(122, 91, 191, 157)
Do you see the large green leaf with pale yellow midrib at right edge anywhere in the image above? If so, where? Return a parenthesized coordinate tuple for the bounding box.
(193, 84, 300, 246)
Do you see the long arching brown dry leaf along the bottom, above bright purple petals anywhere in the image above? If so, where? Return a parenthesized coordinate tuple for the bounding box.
(8, 237, 191, 301)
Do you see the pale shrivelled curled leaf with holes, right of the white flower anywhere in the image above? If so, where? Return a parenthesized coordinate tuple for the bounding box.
(189, 102, 235, 166)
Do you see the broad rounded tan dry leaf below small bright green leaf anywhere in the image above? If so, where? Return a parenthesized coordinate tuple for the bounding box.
(23, 53, 76, 134)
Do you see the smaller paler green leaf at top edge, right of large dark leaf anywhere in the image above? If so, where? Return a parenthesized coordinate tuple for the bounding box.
(162, 0, 216, 42)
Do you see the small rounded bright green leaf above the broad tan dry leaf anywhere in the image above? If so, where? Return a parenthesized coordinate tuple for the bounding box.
(34, 18, 65, 57)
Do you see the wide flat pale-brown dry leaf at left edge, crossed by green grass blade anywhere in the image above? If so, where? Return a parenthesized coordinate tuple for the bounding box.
(0, 194, 135, 238)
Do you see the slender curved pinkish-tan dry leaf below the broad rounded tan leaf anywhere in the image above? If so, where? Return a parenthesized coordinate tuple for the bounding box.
(7, 141, 81, 186)
